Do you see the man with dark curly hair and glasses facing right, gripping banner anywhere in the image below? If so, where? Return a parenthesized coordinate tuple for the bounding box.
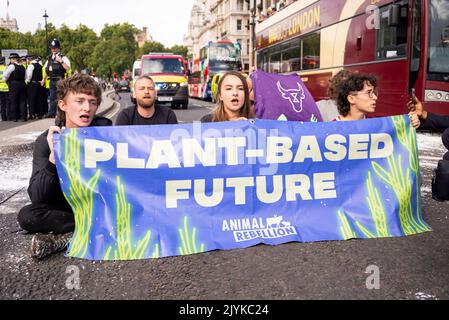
(335, 74, 420, 128)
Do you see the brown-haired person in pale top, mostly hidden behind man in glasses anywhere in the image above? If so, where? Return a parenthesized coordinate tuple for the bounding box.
(316, 69, 352, 121)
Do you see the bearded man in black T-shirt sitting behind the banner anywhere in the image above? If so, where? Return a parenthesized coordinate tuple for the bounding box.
(115, 76, 178, 126)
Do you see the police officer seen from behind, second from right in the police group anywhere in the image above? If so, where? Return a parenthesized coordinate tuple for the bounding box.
(25, 56, 43, 119)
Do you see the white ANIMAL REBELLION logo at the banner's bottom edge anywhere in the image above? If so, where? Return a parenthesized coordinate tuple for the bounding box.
(222, 215, 298, 242)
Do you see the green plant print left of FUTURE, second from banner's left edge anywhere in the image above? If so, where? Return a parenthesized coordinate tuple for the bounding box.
(104, 177, 159, 260)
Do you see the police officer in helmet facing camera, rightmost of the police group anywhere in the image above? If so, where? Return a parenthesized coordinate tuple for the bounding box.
(41, 39, 70, 118)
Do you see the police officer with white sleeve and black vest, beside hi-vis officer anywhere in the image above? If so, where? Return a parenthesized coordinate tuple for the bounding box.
(3, 52, 28, 122)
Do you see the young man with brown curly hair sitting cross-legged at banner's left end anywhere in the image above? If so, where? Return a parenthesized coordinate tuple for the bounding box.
(17, 74, 112, 259)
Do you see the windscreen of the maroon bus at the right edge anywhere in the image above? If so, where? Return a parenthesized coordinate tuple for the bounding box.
(428, 0, 449, 80)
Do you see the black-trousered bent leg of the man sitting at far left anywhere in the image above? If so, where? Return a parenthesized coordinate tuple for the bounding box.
(17, 204, 75, 234)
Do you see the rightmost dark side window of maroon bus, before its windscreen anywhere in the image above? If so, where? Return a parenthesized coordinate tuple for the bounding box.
(377, 0, 408, 59)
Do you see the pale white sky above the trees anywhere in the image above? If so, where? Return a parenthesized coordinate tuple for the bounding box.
(0, 0, 194, 47)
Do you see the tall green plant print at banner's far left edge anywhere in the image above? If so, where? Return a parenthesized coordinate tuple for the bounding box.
(64, 129, 100, 258)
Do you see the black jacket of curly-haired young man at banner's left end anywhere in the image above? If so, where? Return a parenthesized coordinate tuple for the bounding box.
(28, 117, 112, 212)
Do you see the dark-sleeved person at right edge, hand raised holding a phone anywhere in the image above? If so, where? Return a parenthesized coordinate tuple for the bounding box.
(407, 97, 449, 160)
